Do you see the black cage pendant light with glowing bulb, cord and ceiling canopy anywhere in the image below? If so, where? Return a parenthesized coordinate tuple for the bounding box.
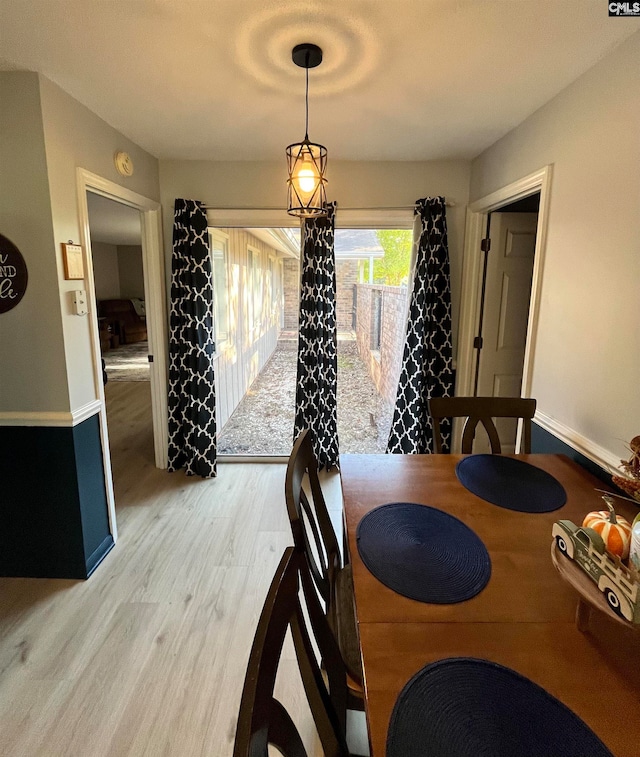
(287, 43, 327, 218)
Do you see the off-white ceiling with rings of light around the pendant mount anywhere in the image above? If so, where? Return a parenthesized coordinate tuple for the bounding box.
(0, 0, 640, 160)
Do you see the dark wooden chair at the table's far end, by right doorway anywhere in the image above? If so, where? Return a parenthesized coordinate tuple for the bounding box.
(429, 397, 536, 455)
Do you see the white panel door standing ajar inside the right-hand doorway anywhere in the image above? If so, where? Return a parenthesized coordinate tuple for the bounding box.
(474, 213, 538, 453)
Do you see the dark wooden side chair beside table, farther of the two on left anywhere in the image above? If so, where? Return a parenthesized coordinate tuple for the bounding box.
(285, 430, 364, 710)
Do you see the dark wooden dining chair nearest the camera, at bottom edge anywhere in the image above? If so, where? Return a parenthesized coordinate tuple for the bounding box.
(233, 547, 349, 757)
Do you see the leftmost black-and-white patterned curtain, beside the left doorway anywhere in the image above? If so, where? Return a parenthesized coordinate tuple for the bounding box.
(168, 199, 216, 478)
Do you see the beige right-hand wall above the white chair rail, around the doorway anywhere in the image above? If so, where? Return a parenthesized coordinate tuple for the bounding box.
(471, 32, 640, 458)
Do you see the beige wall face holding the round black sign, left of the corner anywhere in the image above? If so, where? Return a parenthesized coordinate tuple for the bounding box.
(0, 71, 69, 415)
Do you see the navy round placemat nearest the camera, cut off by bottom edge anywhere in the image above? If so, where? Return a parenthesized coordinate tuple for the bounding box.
(387, 657, 613, 757)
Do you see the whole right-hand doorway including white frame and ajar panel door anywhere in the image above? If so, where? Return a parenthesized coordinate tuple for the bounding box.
(453, 166, 551, 452)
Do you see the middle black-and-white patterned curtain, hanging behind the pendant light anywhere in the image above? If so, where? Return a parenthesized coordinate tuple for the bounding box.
(293, 203, 338, 469)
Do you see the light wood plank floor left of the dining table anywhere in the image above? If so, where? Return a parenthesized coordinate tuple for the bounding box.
(0, 382, 356, 757)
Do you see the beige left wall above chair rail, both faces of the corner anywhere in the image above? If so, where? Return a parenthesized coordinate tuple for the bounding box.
(0, 71, 159, 416)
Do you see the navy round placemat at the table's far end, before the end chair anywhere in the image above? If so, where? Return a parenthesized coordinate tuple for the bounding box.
(456, 455, 567, 513)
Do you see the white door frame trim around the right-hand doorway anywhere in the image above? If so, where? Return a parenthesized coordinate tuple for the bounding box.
(456, 165, 552, 442)
